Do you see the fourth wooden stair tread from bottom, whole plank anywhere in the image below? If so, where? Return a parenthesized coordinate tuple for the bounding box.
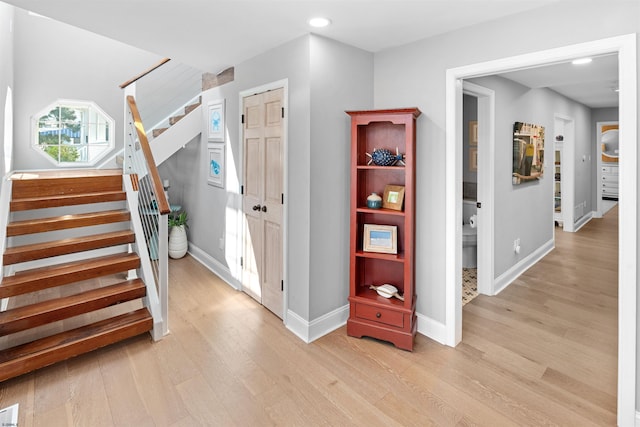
(3, 230, 135, 265)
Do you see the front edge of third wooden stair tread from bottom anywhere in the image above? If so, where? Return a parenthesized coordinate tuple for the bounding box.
(0, 259, 140, 298)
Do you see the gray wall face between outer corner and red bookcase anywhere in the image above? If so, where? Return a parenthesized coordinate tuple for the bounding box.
(309, 36, 373, 320)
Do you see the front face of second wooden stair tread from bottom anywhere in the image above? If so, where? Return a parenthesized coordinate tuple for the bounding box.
(0, 282, 147, 336)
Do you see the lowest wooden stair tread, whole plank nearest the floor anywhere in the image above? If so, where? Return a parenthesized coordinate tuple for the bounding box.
(0, 308, 153, 381)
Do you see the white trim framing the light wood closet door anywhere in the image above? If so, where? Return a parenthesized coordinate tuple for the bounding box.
(236, 79, 289, 325)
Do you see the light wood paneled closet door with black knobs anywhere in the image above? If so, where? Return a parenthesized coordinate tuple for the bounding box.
(242, 89, 284, 317)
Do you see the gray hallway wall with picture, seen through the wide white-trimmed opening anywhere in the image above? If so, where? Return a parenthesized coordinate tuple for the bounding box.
(473, 76, 595, 277)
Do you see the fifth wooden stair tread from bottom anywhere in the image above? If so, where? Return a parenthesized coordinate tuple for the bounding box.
(7, 209, 131, 237)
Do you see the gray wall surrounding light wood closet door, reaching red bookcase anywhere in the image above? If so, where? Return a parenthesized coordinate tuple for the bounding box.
(170, 35, 373, 321)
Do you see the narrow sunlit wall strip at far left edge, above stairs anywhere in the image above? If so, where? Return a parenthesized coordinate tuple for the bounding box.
(0, 3, 15, 176)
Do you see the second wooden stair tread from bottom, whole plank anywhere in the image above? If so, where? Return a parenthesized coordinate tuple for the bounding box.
(0, 279, 146, 336)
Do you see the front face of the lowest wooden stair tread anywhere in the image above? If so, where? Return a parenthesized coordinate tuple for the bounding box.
(0, 310, 153, 382)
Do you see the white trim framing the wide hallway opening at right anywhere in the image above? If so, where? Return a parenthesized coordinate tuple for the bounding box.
(445, 33, 638, 425)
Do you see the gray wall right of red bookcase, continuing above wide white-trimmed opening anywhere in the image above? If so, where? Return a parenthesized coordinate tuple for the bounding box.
(374, 2, 640, 330)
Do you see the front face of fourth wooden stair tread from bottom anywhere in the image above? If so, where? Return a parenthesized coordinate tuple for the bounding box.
(3, 232, 135, 265)
